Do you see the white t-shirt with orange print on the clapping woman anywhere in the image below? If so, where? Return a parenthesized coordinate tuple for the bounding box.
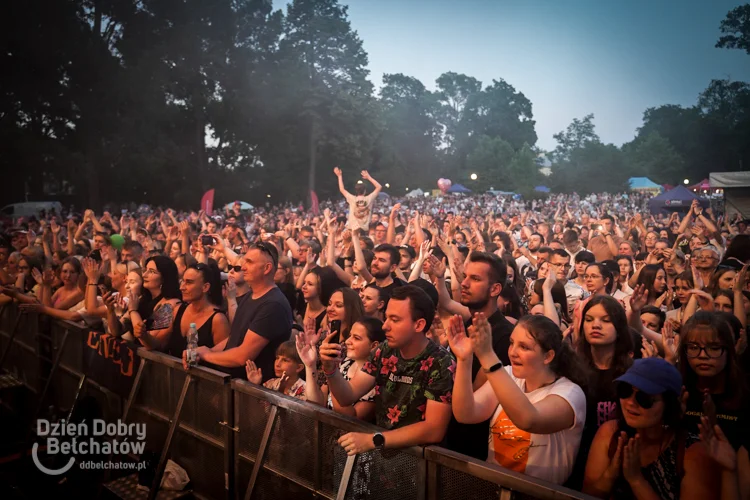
(487, 366, 586, 484)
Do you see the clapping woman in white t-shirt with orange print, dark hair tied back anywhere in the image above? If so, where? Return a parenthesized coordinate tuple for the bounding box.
(449, 314, 587, 484)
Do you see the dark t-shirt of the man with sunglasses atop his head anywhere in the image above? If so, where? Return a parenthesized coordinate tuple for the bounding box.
(224, 286, 292, 382)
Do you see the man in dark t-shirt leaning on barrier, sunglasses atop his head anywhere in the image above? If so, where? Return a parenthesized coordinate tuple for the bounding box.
(183, 243, 292, 382)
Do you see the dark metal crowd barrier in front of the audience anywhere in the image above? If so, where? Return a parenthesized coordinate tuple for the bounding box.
(0, 311, 591, 500)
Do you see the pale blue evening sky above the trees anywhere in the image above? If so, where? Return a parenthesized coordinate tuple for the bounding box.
(274, 0, 750, 150)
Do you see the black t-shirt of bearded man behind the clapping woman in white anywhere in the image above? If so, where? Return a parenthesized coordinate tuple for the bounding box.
(446, 311, 514, 460)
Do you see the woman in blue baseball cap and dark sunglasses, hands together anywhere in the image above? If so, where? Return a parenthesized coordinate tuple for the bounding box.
(583, 358, 720, 499)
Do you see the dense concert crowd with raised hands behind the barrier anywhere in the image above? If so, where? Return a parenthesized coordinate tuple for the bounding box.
(0, 169, 750, 499)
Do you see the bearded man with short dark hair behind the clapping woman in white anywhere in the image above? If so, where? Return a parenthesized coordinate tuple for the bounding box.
(430, 252, 513, 460)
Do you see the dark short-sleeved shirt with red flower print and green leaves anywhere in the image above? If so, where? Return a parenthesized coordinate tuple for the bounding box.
(362, 341, 456, 429)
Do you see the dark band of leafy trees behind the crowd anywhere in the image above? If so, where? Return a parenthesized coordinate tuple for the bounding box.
(0, 0, 750, 207)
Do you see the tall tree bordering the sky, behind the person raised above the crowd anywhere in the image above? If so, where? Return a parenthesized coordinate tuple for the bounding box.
(281, 0, 374, 199)
